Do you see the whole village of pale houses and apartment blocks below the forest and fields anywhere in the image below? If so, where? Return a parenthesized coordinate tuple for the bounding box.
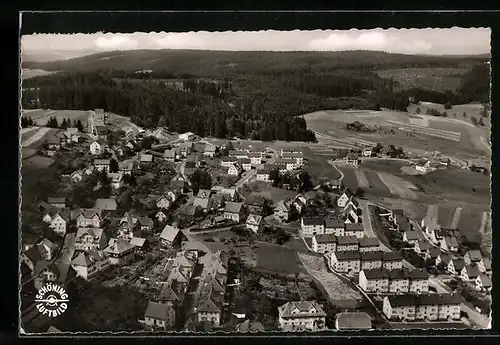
(21, 109, 491, 332)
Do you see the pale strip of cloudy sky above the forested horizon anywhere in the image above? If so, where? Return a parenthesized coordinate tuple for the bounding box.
(21, 27, 491, 55)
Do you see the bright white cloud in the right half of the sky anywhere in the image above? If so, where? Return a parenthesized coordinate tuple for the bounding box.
(308, 31, 432, 54)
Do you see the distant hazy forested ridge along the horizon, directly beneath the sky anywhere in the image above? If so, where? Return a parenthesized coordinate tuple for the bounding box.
(23, 50, 490, 76)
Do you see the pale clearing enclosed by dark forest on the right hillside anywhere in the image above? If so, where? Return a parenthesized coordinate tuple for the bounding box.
(376, 68, 468, 91)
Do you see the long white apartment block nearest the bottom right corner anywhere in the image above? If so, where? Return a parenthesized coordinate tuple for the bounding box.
(382, 294, 462, 321)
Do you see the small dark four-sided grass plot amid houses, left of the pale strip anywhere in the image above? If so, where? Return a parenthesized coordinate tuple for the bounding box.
(256, 242, 307, 275)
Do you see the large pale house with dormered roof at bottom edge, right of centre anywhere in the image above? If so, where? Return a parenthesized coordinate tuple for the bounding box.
(278, 301, 326, 331)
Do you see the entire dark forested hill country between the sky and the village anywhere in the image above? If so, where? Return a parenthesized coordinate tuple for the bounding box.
(22, 50, 490, 141)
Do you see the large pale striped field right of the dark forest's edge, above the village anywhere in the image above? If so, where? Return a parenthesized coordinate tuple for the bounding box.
(303, 104, 489, 159)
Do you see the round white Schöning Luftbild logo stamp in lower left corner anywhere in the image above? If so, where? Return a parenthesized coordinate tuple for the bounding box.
(35, 283, 69, 317)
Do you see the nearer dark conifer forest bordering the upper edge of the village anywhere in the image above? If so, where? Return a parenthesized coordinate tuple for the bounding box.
(22, 73, 315, 141)
